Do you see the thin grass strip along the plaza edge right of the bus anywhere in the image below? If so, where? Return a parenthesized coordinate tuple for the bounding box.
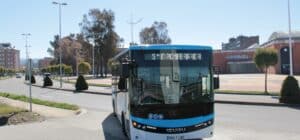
(215, 90, 280, 95)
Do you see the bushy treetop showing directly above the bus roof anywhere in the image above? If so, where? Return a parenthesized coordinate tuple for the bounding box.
(140, 21, 172, 44)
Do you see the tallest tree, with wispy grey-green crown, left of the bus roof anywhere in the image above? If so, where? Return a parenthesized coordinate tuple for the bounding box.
(79, 9, 121, 77)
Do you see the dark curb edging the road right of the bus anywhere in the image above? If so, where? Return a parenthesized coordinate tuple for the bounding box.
(215, 100, 300, 108)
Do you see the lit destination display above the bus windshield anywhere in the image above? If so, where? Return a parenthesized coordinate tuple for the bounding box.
(145, 53, 202, 61)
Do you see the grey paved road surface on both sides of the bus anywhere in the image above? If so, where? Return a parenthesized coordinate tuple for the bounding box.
(0, 79, 300, 140)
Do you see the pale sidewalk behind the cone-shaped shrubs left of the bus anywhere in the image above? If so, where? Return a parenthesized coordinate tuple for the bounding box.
(33, 76, 111, 95)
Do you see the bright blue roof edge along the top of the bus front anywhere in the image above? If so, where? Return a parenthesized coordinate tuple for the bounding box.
(129, 44, 212, 50)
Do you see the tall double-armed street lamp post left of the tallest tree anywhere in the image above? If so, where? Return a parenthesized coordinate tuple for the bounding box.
(52, 1, 67, 88)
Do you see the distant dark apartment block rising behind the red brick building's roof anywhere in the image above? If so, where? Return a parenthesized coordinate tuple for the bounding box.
(222, 35, 259, 50)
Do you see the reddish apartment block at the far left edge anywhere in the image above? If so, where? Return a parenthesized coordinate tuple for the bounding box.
(0, 43, 20, 69)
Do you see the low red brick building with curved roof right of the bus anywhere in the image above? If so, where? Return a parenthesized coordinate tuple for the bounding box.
(213, 32, 300, 74)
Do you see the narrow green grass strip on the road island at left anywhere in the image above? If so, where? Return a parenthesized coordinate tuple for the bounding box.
(0, 92, 79, 110)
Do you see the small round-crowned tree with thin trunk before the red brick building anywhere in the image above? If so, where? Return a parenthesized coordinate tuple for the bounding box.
(254, 48, 278, 93)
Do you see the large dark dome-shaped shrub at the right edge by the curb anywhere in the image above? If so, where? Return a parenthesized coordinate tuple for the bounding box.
(279, 76, 300, 104)
